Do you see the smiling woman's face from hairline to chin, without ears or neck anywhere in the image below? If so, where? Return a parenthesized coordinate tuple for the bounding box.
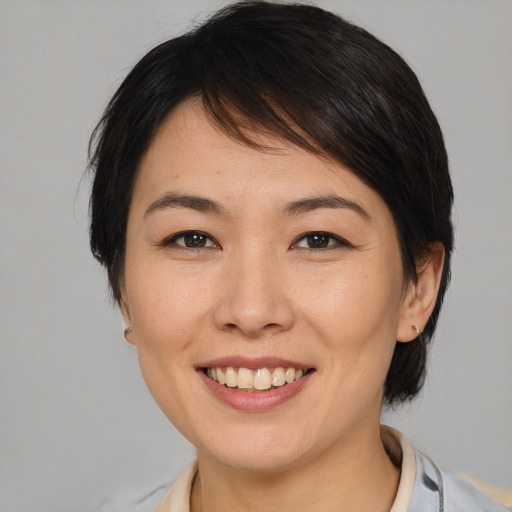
(123, 101, 416, 470)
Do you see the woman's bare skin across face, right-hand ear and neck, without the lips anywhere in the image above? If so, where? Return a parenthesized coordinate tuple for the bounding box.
(122, 100, 443, 512)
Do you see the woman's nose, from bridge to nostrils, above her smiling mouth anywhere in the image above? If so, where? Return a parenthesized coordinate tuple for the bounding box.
(214, 247, 295, 338)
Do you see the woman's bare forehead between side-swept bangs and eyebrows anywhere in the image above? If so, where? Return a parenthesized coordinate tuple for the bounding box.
(133, 99, 386, 221)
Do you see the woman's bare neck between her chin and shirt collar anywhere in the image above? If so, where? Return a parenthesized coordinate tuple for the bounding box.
(191, 424, 400, 512)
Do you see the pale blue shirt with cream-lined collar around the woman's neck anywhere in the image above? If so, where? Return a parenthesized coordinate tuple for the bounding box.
(147, 427, 510, 512)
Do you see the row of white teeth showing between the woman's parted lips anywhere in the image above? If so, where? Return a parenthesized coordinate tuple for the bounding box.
(203, 366, 314, 392)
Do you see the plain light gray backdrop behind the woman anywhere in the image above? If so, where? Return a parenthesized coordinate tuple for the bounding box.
(0, 0, 512, 512)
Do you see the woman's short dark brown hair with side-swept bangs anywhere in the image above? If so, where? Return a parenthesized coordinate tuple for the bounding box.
(89, 1, 453, 404)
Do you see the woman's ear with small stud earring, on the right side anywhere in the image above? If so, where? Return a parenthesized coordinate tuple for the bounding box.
(396, 242, 445, 342)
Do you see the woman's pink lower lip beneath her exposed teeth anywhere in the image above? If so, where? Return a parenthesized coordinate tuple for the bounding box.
(197, 370, 315, 412)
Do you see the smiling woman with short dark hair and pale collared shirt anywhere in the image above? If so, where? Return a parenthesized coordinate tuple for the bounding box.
(91, 2, 505, 512)
